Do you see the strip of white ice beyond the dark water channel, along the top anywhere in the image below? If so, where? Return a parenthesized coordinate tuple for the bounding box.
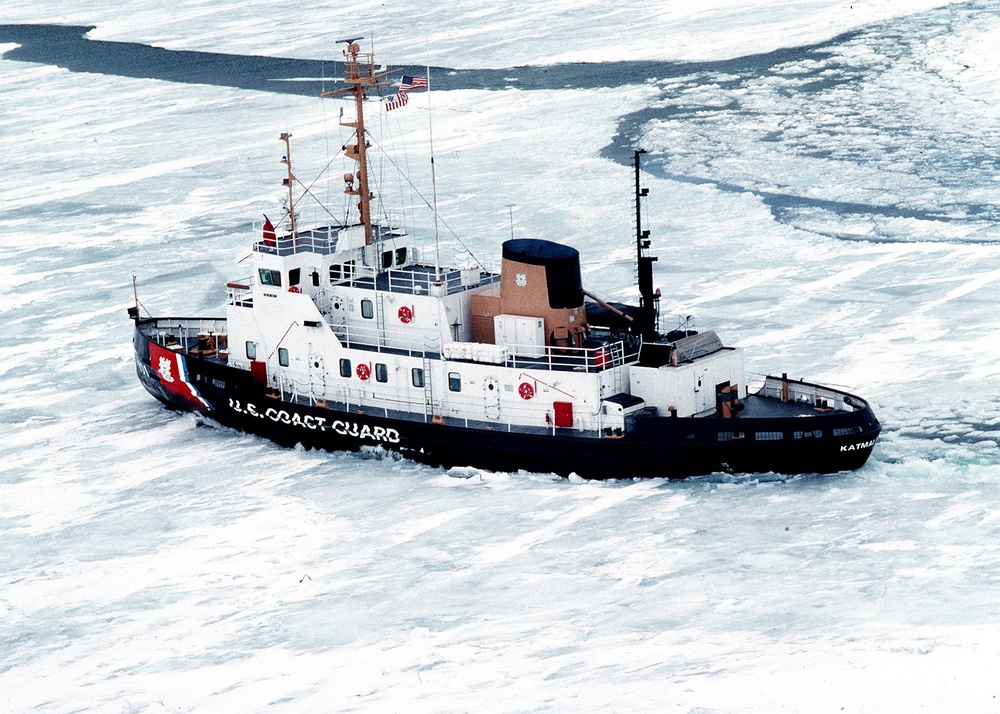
(4, 0, 968, 67)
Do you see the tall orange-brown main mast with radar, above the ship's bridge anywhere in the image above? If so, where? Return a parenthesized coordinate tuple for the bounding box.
(322, 37, 389, 245)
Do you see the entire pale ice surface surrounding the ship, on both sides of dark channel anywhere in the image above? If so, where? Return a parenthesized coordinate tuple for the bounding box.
(0, 0, 1000, 713)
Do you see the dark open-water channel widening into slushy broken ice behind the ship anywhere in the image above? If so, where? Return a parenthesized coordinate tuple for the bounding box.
(0, 0, 1000, 243)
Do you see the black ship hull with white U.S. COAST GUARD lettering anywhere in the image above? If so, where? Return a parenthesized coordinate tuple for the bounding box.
(135, 322, 881, 479)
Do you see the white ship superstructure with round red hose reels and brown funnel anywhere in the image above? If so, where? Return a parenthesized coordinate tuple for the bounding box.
(227, 226, 746, 435)
